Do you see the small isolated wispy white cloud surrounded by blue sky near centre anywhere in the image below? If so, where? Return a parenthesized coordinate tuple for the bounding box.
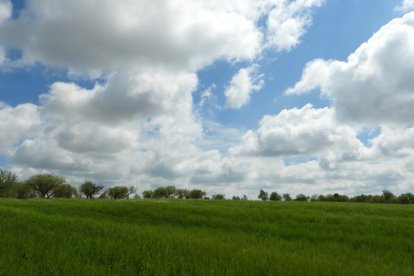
(224, 64, 264, 109)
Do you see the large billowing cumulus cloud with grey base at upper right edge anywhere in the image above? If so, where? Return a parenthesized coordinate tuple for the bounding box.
(286, 12, 414, 124)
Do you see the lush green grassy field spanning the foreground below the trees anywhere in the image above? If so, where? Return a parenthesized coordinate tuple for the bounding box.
(0, 200, 414, 275)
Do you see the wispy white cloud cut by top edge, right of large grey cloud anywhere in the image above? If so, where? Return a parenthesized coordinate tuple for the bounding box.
(266, 0, 325, 51)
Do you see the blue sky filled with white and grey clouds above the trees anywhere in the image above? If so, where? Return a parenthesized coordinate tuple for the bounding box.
(0, 0, 414, 198)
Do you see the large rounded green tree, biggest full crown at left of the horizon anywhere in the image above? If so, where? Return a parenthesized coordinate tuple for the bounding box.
(26, 173, 65, 198)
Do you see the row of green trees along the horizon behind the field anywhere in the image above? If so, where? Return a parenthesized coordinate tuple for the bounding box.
(0, 169, 414, 204)
